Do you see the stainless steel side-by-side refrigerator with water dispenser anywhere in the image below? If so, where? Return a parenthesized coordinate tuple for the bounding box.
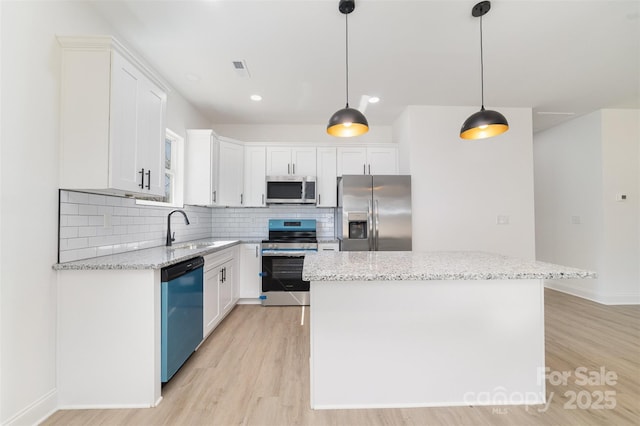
(336, 175, 411, 251)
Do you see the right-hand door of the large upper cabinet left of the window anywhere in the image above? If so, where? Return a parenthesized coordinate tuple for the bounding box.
(137, 80, 167, 196)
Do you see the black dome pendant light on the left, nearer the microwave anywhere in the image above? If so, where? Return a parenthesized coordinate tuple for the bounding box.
(327, 0, 369, 137)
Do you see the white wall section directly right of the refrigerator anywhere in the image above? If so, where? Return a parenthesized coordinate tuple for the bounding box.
(394, 106, 535, 259)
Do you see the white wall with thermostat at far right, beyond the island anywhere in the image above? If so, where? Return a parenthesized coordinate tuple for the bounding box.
(534, 110, 640, 304)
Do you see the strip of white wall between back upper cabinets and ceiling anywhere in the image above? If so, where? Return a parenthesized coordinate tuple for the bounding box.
(212, 122, 395, 143)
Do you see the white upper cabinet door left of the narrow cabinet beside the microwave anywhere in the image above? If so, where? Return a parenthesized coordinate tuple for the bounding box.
(218, 140, 244, 207)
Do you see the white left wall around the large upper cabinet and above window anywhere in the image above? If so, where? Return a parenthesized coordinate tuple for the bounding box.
(0, 1, 208, 424)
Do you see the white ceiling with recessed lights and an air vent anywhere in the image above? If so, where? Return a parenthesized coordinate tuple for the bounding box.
(91, 0, 640, 131)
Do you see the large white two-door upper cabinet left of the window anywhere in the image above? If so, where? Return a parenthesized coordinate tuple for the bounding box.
(58, 36, 167, 197)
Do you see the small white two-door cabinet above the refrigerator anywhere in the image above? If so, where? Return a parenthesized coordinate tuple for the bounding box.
(337, 146, 398, 176)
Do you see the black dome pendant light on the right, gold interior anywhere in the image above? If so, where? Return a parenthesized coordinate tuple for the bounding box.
(460, 1, 509, 139)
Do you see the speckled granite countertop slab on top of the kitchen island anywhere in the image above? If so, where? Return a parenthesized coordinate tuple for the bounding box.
(302, 251, 596, 281)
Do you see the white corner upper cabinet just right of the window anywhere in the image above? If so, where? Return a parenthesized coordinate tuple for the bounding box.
(184, 129, 244, 206)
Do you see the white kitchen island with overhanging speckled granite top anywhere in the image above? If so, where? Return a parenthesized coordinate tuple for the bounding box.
(303, 252, 595, 409)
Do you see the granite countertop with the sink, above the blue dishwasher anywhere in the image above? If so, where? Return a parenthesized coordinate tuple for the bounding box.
(53, 239, 242, 271)
